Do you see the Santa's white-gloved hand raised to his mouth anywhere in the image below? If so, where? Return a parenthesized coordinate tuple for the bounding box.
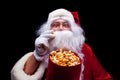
(34, 30, 54, 61)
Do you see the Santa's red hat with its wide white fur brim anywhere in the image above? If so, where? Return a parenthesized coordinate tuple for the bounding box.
(47, 8, 80, 25)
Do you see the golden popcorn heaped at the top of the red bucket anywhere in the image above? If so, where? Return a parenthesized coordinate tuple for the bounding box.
(50, 49, 81, 66)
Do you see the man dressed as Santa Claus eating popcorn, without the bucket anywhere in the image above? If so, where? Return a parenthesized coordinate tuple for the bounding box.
(11, 8, 113, 80)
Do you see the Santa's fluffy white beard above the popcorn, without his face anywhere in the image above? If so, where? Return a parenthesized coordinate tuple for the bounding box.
(50, 30, 82, 53)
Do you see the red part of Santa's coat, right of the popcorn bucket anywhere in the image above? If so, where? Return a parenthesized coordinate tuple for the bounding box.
(82, 44, 113, 80)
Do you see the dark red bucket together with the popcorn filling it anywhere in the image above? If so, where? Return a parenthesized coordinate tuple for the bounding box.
(46, 49, 82, 80)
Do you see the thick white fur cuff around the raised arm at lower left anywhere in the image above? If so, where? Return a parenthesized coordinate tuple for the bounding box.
(11, 52, 45, 80)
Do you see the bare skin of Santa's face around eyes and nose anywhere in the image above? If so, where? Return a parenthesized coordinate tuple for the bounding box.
(50, 18, 71, 31)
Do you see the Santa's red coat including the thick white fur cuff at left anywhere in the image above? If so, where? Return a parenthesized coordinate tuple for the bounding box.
(11, 44, 113, 80)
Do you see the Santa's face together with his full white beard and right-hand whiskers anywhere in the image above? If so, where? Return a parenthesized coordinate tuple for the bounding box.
(50, 18, 84, 52)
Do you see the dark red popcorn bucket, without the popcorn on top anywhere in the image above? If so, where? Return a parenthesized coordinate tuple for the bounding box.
(46, 51, 81, 80)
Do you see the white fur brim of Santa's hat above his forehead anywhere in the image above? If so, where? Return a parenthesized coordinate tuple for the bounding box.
(48, 8, 75, 21)
